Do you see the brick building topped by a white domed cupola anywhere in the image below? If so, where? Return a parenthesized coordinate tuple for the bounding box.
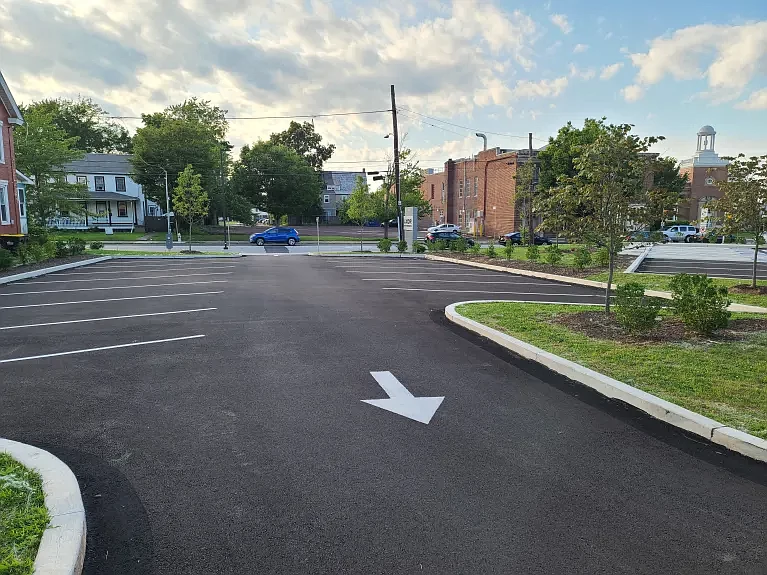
(677, 126, 728, 227)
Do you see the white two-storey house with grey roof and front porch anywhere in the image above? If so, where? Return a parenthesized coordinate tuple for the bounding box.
(48, 154, 163, 234)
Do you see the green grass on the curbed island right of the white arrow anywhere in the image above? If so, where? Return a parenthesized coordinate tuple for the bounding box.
(458, 303, 767, 439)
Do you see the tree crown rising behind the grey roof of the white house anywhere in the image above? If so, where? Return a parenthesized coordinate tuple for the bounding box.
(22, 98, 132, 153)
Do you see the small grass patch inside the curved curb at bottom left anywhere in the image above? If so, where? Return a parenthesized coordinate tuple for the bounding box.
(0, 453, 50, 575)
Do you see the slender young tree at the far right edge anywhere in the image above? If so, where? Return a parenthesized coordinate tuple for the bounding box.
(712, 154, 767, 288)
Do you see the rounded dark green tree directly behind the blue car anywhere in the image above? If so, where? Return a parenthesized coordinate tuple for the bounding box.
(231, 141, 322, 221)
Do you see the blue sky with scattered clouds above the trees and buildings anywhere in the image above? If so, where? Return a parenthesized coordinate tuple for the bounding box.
(0, 0, 767, 171)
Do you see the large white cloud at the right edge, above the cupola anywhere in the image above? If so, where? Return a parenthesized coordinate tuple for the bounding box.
(631, 21, 767, 105)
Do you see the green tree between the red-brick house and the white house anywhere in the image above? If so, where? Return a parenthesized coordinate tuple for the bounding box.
(15, 109, 88, 226)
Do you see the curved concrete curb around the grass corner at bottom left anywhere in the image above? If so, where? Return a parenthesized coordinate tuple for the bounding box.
(0, 438, 86, 575)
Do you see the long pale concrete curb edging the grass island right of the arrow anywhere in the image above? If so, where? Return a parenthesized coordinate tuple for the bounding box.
(445, 300, 767, 462)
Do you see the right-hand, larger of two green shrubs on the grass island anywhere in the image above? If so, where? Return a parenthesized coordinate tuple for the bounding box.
(670, 274, 730, 335)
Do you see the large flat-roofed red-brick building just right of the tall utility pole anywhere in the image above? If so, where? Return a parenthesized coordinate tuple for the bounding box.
(421, 148, 537, 241)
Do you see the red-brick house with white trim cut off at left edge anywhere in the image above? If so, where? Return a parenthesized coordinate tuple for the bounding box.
(0, 69, 27, 247)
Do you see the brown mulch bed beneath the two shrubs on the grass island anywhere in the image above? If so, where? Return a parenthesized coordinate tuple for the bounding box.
(551, 311, 767, 343)
